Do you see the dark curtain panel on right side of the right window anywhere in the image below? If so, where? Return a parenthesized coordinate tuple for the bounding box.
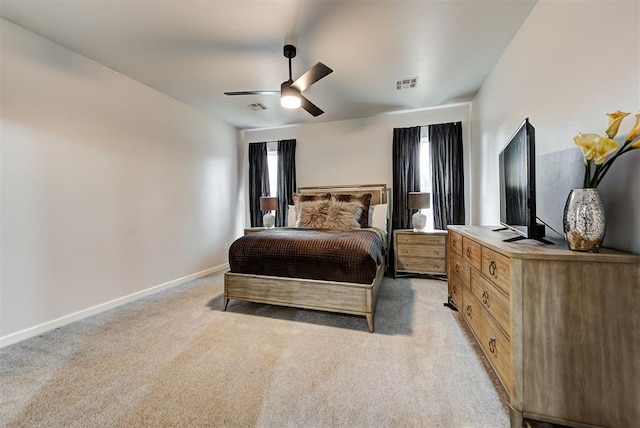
(429, 122, 464, 230)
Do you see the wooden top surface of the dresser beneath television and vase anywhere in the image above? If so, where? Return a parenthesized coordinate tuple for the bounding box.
(448, 225, 640, 263)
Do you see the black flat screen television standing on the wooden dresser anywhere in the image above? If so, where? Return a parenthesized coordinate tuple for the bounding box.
(499, 118, 551, 244)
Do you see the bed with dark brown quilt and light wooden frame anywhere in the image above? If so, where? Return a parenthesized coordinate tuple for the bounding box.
(223, 185, 389, 332)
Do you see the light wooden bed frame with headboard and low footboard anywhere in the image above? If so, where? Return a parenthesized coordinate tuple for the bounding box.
(222, 184, 389, 332)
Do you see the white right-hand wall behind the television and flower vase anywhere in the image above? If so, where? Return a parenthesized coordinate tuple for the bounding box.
(471, 0, 640, 253)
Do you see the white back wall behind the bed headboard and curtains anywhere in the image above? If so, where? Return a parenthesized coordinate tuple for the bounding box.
(241, 103, 470, 225)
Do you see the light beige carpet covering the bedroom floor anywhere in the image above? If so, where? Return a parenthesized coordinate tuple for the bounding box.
(0, 273, 509, 428)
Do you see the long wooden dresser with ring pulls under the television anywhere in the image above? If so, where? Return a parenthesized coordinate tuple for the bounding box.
(447, 226, 640, 427)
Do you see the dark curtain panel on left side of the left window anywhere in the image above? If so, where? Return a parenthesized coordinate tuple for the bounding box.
(249, 143, 269, 227)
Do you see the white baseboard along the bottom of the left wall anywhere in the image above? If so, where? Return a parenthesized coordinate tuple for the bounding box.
(0, 263, 229, 348)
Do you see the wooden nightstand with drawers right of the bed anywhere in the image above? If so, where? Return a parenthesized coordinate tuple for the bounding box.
(393, 229, 447, 277)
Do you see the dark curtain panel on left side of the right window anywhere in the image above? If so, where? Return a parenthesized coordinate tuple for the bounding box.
(391, 126, 420, 230)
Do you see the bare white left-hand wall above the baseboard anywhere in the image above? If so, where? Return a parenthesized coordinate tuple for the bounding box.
(0, 20, 240, 344)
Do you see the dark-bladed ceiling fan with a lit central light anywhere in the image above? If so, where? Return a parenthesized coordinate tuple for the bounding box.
(224, 45, 333, 116)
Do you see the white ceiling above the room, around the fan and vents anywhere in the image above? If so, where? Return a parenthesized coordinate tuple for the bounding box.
(0, 0, 537, 129)
